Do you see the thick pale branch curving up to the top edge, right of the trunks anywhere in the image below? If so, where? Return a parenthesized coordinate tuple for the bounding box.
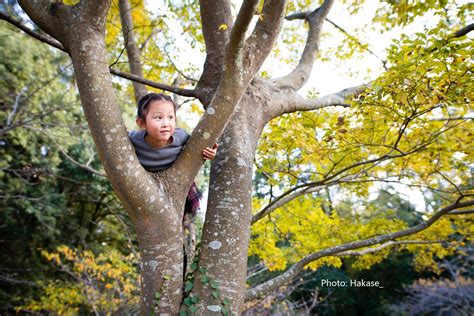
(272, 0, 334, 90)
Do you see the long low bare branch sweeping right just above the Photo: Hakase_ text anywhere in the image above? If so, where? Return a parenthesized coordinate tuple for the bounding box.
(245, 196, 474, 301)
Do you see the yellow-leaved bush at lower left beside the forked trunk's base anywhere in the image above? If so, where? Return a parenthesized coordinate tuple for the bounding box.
(17, 246, 140, 315)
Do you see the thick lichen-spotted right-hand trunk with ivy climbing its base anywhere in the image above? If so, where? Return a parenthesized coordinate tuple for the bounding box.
(195, 87, 263, 314)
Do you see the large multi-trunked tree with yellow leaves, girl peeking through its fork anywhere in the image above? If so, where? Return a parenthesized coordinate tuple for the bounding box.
(2, 1, 473, 313)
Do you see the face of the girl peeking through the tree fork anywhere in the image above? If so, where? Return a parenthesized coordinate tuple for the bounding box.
(136, 100, 176, 148)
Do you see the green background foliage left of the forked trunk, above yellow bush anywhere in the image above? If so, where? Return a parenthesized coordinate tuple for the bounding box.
(0, 16, 133, 314)
